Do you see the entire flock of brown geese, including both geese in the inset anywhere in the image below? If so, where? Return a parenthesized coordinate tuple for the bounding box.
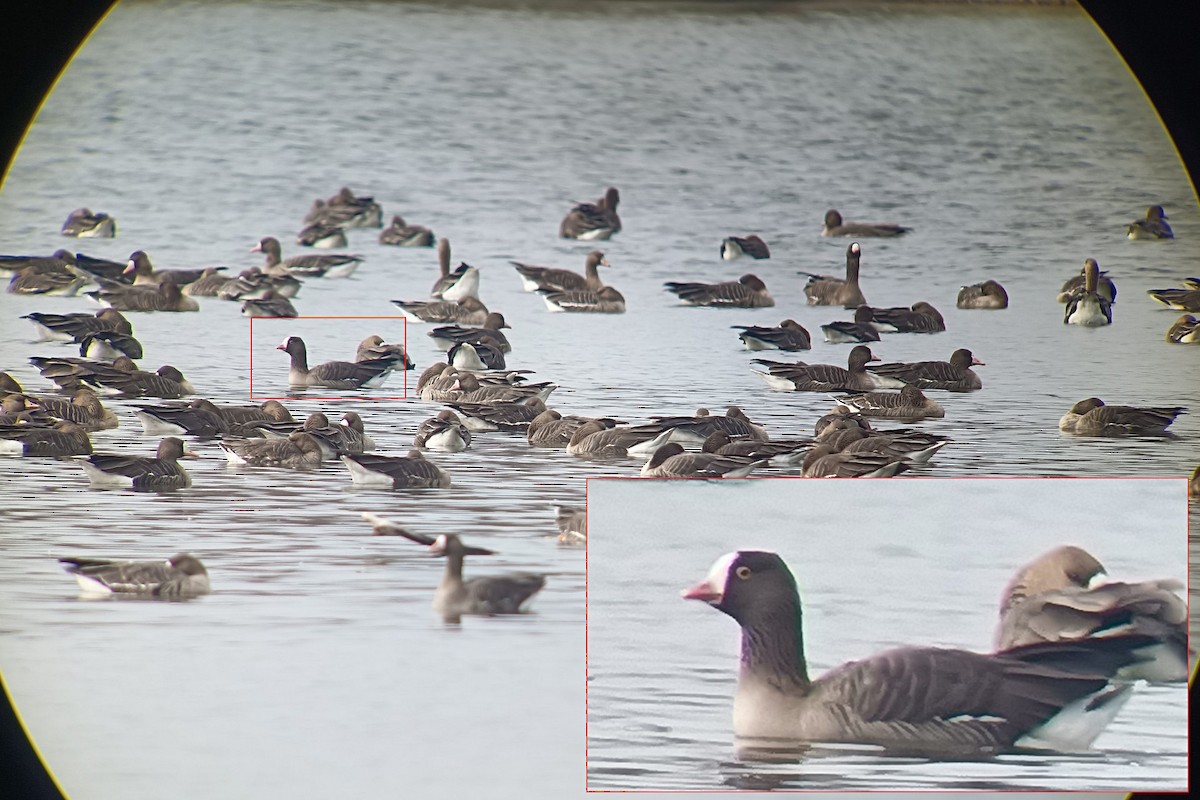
(0, 187, 1200, 752)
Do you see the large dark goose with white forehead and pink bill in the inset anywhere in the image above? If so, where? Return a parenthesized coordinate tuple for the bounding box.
(682, 551, 1145, 758)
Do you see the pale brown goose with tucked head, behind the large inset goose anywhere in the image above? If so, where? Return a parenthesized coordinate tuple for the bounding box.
(995, 545, 1195, 682)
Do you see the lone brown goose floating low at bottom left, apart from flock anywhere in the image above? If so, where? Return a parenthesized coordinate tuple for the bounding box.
(59, 553, 212, 600)
